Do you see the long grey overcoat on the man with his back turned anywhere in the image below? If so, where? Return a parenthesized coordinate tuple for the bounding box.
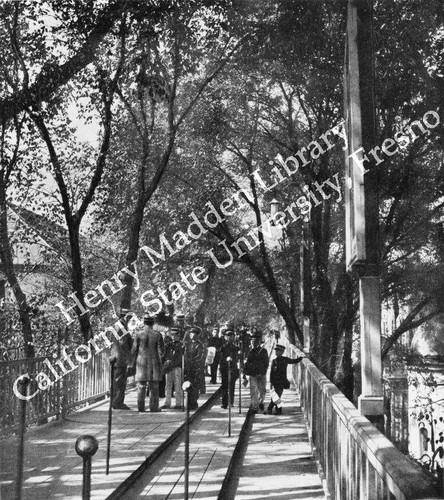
(133, 326, 165, 382)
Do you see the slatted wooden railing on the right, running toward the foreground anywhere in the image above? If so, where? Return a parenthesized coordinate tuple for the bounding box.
(289, 346, 441, 500)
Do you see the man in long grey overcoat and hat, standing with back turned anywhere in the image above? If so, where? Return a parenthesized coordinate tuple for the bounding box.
(132, 314, 165, 412)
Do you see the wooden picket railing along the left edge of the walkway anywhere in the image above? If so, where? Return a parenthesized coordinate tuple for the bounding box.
(0, 351, 110, 433)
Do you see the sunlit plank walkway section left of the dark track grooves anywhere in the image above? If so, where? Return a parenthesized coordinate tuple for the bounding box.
(0, 385, 219, 500)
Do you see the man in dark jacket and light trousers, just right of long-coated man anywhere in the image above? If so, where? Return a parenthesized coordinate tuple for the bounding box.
(162, 326, 183, 410)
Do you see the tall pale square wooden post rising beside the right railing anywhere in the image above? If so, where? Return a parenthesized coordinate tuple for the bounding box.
(344, 0, 383, 423)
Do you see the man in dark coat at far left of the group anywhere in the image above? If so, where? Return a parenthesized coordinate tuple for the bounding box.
(110, 309, 133, 410)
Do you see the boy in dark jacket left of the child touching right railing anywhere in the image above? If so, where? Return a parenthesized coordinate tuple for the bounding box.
(244, 333, 268, 414)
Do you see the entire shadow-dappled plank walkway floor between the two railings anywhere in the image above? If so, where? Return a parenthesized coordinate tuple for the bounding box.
(0, 385, 324, 500)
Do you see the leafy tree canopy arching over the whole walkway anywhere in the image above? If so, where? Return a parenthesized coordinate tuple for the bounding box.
(0, 0, 444, 398)
